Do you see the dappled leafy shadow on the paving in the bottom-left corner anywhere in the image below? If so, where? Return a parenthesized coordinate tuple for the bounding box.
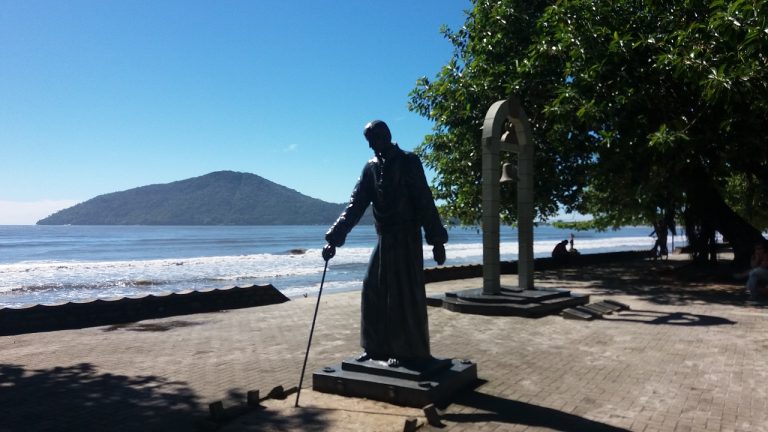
(0, 363, 201, 432)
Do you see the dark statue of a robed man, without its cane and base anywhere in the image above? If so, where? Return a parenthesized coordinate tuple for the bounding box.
(323, 120, 448, 366)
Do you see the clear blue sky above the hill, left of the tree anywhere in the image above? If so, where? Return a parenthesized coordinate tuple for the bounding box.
(0, 0, 471, 224)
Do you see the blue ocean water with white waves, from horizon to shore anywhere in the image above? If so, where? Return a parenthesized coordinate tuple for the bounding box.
(0, 225, 683, 307)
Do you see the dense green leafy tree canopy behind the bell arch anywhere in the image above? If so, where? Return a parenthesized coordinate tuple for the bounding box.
(410, 0, 768, 261)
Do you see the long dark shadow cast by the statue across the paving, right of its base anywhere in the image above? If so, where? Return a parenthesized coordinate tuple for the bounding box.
(441, 381, 627, 432)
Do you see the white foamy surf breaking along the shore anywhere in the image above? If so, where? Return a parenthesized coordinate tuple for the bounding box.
(0, 236, 664, 307)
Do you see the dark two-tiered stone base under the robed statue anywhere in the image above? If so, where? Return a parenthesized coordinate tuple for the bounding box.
(312, 358, 477, 408)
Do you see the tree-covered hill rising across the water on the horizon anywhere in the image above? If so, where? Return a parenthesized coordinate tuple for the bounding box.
(37, 171, 370, 225)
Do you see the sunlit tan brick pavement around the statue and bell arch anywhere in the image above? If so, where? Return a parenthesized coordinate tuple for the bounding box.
(0, 261, 768, 432)
